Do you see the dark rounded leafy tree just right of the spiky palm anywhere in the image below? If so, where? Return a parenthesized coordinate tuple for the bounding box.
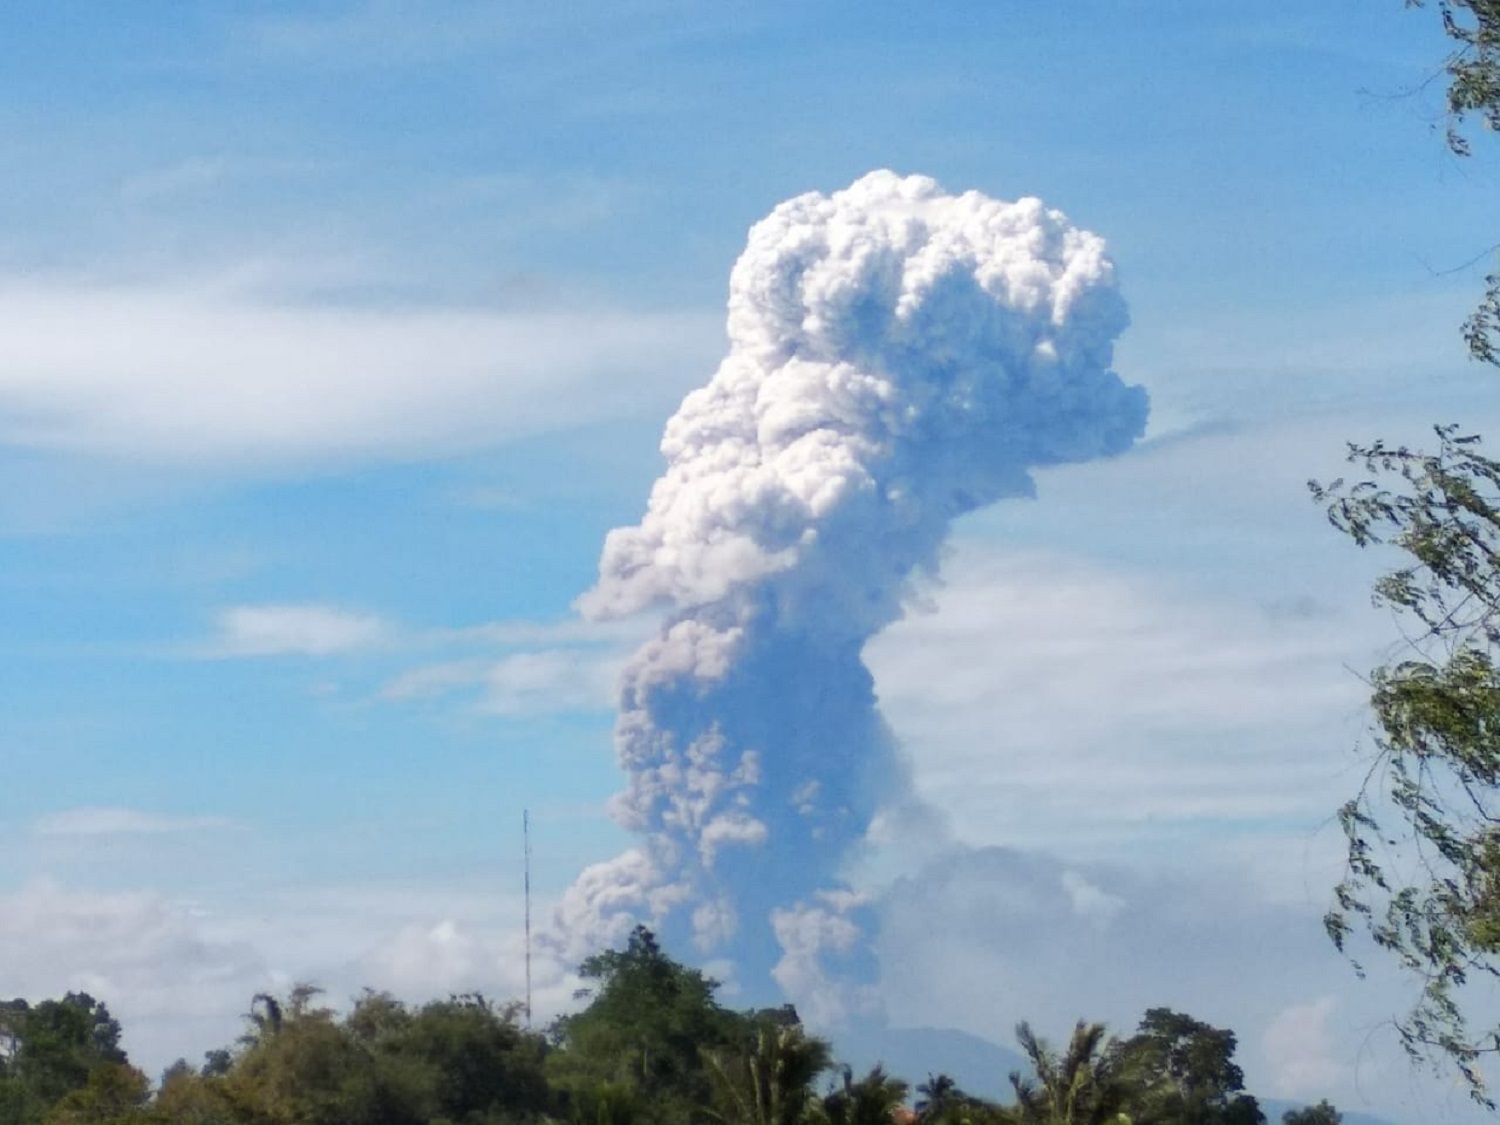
(1104, 1008, 1266, 1125)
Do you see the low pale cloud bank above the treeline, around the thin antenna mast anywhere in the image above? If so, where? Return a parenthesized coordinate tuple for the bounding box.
(0, 879, 588, 1074)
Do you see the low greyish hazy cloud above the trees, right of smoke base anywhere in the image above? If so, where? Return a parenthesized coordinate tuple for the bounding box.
(878, 848, 1458, 1122)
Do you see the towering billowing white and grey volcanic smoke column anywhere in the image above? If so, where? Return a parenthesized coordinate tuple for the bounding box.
(560, 171, 1146, 1020)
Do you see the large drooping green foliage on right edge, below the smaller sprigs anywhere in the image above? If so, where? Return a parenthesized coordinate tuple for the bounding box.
(1313, 426, 1500, 1107)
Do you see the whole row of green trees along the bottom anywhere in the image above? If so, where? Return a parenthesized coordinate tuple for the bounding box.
(0, 927, 1340, 1125)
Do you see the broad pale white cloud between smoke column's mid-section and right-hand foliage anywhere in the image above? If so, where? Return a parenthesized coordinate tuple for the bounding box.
(867, 542, 1368, 854)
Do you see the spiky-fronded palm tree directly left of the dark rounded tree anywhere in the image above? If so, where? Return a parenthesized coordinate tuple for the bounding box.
(1011, 1020, 1130, 1125)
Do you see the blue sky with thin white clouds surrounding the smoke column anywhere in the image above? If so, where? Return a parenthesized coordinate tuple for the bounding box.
(0, 0, 1497, 1121)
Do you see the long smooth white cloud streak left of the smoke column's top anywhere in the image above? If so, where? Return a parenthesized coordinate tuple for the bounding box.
(0, 286, 722, 468)
